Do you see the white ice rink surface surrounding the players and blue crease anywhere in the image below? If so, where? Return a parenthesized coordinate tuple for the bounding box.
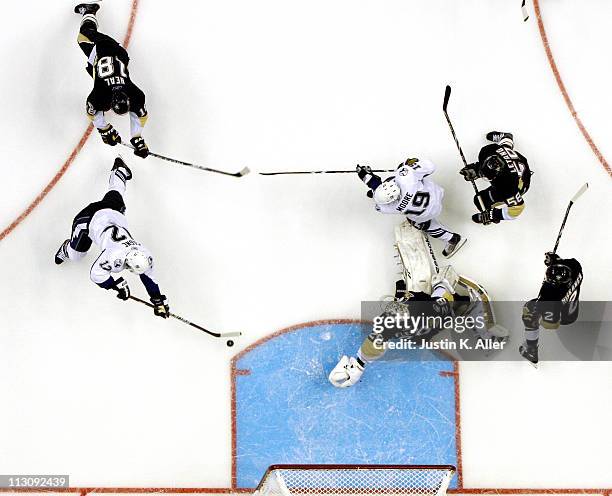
(0, 0, 612, 489)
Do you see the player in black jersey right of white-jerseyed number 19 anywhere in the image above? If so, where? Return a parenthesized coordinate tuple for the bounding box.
(460, 131, 531, 225)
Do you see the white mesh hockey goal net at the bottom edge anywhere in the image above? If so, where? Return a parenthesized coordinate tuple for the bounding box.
(255, 465, 455, 496)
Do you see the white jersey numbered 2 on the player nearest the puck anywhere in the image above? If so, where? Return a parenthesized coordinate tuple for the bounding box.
(89, 208, 156, 284)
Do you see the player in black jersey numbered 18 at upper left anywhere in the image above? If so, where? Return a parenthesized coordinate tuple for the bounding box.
(74, 2, 149, 158)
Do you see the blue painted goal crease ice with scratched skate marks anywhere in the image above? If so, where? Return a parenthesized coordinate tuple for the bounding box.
(232, 321, 457, 488)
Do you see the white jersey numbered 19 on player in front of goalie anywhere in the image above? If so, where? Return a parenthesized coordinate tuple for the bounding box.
(376, 159, 444, 223)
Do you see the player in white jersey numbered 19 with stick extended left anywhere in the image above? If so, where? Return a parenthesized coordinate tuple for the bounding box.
(357, 158, 466, 258)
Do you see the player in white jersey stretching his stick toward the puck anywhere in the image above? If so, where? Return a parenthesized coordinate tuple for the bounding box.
(55, 157, 170, 318)
